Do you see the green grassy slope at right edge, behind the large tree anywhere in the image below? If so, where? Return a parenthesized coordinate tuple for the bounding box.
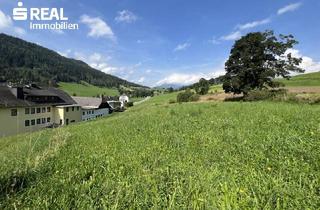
(277, 72, 320, 87)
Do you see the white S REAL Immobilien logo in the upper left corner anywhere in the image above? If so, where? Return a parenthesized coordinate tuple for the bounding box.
(12, 2, 79, 30)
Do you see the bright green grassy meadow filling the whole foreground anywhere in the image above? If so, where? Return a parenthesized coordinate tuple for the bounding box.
(0, 94, 320, 209)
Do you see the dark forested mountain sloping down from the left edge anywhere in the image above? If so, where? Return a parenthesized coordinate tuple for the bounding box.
(0, 33, 142, 87)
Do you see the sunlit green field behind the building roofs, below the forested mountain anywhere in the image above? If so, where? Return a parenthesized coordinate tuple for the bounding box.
(59, 82, 119, 97)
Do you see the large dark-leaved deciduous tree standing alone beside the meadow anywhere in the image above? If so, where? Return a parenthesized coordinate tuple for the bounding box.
(223, 31, 304, 95)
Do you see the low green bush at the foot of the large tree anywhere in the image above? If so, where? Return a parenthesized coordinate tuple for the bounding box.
(243, 89, 287, 101)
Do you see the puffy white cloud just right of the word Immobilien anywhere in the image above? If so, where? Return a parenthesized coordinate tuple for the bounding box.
(80, 15, 115, 40)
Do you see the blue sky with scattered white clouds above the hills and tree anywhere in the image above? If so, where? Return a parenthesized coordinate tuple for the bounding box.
(0, 0, 320, 86)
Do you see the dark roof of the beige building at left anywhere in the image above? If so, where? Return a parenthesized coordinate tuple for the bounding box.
(0, 86, 76, 107)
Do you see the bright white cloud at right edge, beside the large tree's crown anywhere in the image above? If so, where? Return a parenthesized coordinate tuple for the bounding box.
(286, 49, 320, 73)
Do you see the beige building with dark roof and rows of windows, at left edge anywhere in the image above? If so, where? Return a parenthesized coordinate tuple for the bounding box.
(0, 85, 82, 137)
